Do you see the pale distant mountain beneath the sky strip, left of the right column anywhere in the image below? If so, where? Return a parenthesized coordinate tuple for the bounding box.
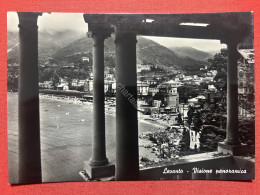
(170, 47, 213, 61)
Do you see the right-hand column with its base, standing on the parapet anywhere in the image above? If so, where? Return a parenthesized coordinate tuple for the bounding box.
(218, 36, 247, 155)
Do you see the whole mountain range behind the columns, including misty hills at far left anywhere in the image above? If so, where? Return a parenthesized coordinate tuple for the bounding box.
(7, 31, 209, 71)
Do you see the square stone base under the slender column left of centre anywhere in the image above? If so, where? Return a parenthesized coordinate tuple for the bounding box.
(83, 161, 115, 179)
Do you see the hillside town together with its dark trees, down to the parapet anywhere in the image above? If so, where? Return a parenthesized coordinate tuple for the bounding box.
(9, 46, 254, 162)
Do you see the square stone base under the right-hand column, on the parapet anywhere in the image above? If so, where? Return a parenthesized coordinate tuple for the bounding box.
(218, 142, 249, 156)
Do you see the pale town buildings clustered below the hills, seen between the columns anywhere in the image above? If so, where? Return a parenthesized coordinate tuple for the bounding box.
(27, 49, 254, 125)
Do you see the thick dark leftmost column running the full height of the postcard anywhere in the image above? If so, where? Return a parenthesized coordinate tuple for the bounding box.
(18, 12, 42, 183)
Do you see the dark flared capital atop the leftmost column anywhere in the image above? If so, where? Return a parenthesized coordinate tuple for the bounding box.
(17, 12, 42, 29)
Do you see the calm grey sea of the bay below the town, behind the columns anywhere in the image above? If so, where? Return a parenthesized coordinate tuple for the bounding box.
(7, 92, 160, 183)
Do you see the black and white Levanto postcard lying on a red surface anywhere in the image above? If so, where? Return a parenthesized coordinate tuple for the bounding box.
(7, 11, 255, 184)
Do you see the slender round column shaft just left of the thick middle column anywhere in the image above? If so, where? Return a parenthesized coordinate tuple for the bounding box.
(90, 35, 108, 165)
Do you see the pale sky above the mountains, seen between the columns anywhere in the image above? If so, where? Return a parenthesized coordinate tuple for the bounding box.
(7, 12, 226, 52)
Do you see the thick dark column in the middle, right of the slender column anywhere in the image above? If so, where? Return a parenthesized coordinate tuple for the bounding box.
(115, 31, 139, 180)
